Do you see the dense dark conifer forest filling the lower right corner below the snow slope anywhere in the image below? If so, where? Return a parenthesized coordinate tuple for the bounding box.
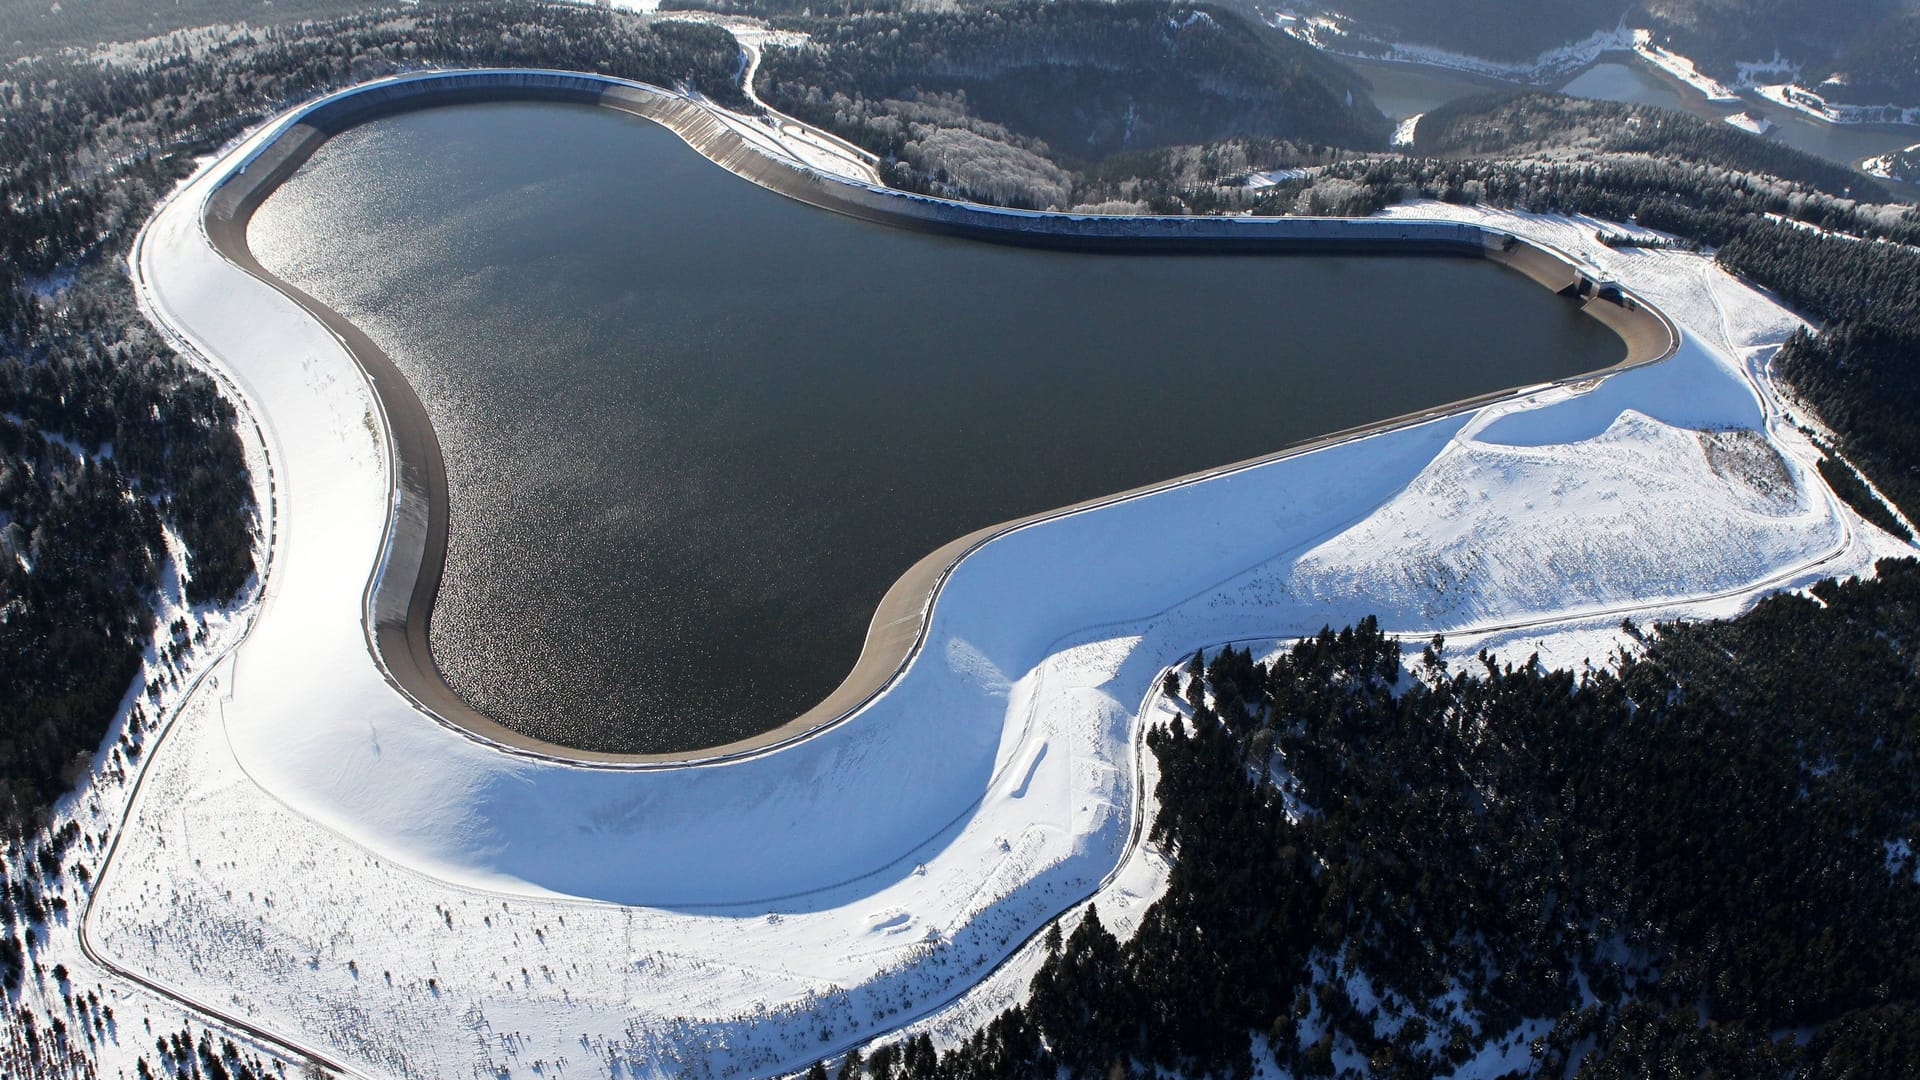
(841, 561, 1920, 1078)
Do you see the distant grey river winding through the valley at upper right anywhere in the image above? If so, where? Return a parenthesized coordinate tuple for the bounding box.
(1340, 54, 1920, 200)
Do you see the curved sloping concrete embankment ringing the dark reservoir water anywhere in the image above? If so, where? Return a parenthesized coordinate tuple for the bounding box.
(204, 71, 1678, 767)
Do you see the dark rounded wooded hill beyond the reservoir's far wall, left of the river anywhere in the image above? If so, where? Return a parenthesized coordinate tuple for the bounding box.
(756, 0, 1386, 208)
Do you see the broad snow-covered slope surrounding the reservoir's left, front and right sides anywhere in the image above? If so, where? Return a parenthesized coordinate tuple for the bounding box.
(22, 75, 1908, 1076)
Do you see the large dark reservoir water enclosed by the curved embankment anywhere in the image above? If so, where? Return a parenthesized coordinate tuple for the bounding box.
(250, 104, 1624, 751)
